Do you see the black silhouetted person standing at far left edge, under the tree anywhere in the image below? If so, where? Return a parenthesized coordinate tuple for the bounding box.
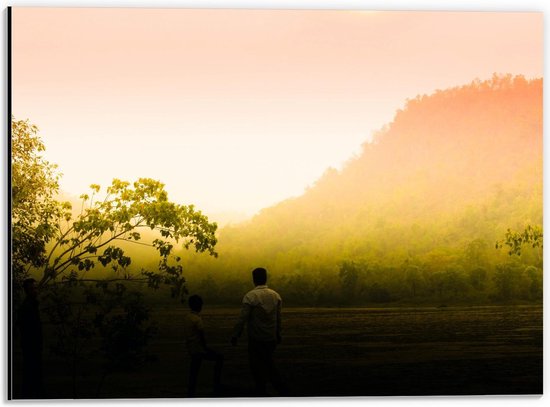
(16, 278, 43, 399)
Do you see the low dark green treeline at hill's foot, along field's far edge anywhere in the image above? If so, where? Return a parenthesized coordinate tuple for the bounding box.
(185, 260, 543, 307)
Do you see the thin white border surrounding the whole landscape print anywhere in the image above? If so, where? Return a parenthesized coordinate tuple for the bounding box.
(0, 0, 550, 407)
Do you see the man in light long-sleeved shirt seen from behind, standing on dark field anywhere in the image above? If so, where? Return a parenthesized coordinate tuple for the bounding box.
(231, 268, 285, 396)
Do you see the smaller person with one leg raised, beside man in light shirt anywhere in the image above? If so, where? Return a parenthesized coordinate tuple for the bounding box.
(184, 295, 224, 397)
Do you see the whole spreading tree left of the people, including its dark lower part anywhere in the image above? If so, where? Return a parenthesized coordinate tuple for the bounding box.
(35, 171, 217, 397)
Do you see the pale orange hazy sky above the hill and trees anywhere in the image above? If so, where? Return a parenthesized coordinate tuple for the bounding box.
(12, 8, 543, 220)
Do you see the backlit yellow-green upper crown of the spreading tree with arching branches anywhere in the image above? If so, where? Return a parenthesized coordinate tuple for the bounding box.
(35, 178, 217, 298)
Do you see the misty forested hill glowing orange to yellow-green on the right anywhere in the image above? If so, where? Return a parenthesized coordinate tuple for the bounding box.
(188, 75, 543, 302)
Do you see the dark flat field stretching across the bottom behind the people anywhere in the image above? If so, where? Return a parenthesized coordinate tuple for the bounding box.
(14, 306, 543, 398)
